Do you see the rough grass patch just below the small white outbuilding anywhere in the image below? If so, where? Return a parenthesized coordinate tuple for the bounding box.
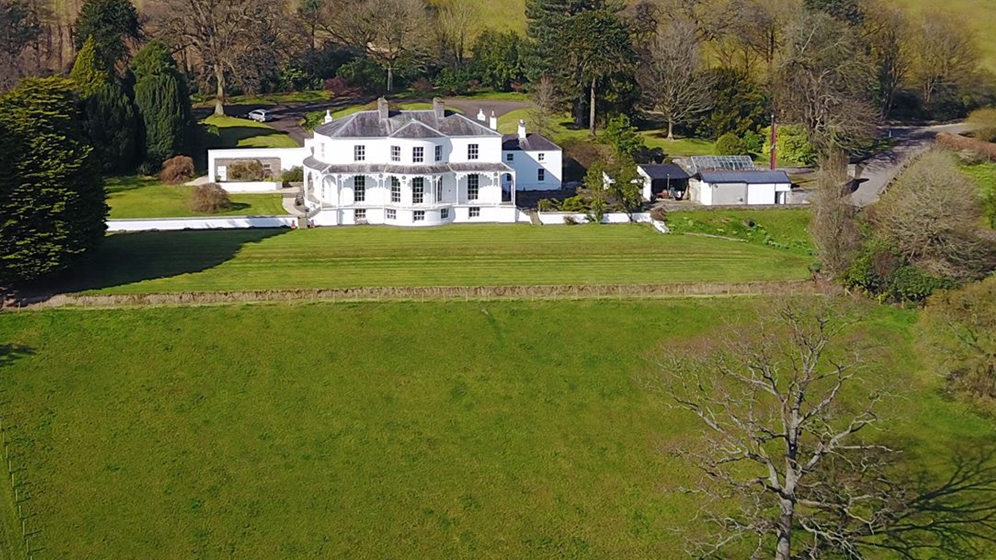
(667, 208, 814, 254)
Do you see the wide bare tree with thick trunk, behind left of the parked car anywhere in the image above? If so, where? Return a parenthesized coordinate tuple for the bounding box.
(148, 0, 292, 115)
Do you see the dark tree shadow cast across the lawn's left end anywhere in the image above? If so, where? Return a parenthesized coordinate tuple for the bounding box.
(17, 228, 289, 300)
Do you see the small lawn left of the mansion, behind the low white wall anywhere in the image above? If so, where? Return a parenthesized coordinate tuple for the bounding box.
(106, 175, 287, 219)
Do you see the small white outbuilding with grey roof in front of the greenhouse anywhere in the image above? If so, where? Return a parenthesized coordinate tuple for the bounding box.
(688, 170, 792, 206)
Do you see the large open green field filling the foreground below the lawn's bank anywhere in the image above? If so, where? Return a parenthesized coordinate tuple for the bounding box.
(0, 299, 996, 559)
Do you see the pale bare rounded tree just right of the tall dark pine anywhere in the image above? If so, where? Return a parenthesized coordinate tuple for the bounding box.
(638, 20, 712, 140)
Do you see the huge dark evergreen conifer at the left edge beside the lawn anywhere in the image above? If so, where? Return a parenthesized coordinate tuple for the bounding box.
(0, 77, 107, 285)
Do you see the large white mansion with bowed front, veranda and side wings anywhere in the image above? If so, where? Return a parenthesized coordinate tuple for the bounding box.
(209, 99, 563, 226)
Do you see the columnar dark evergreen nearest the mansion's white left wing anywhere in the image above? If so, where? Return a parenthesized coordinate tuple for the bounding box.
(132, 41, 193, 168)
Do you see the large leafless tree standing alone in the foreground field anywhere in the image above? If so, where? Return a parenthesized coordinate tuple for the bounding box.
(664, 300, 882, 560)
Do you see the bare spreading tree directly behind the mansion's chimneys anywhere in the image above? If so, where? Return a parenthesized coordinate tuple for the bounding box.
(320, 0, 435, 92)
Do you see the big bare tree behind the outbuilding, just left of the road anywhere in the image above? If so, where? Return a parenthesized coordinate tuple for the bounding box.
(775, 11, 876, 154)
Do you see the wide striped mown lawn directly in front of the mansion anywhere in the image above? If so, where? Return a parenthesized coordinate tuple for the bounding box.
(39, 225, 811, 293)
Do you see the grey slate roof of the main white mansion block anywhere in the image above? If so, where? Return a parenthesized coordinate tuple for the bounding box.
(315, 110, 499, 138)
